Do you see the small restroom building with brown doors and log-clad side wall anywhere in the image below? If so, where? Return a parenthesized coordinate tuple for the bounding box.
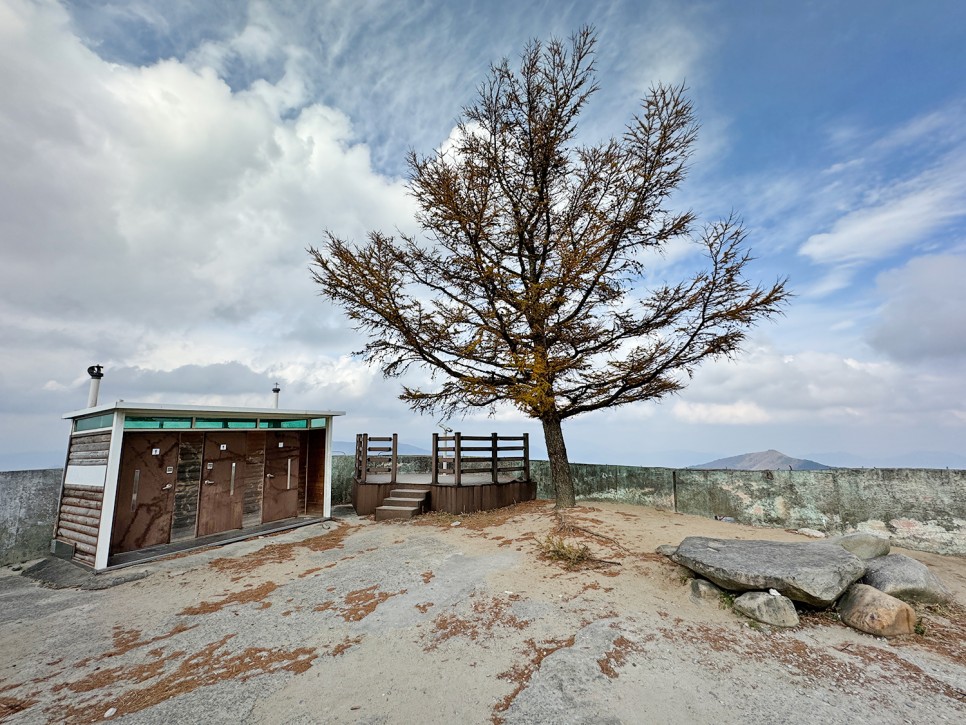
(52, 398, 344, 571)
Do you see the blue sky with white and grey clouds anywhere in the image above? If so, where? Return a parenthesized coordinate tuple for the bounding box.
(0, 0, 966, 469)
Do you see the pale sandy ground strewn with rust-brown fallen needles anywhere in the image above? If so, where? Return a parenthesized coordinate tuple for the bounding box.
(0, 502, 966, 724)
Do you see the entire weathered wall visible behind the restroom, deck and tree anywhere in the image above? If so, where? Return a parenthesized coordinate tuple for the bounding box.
(7, 456, 966, 565)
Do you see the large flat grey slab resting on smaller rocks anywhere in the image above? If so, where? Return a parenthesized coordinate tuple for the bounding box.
(671, 536, 865, 607)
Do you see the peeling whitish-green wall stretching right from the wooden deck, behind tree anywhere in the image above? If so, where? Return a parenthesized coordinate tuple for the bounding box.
(531, 461, 966, 556)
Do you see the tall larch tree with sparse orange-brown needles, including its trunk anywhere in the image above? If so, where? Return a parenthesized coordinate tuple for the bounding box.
(308, 28, 788, 507)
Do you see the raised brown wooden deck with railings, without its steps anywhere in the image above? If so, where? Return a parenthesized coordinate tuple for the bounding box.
(352, 433, 537, 516)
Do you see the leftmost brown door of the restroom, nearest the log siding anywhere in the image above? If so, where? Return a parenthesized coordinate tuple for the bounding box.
(111, 432, 178, 554)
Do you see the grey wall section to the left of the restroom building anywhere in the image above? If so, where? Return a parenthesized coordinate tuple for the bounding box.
(0, 468, 64, 566)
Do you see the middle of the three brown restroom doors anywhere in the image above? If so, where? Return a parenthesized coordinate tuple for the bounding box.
(198, 433, 246, 536)
